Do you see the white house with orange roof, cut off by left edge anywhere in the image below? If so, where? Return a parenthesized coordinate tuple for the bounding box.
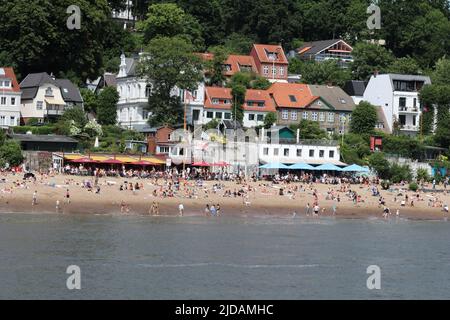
(0, 67, 22, 128)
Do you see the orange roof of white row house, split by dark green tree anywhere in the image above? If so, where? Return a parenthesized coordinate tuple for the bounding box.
(205, 87, 276, 112)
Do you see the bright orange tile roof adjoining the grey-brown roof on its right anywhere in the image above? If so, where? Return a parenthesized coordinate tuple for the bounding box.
(267, 82, 320, 109)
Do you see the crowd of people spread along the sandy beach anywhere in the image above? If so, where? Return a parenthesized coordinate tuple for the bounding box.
(0, 164, 448, 218)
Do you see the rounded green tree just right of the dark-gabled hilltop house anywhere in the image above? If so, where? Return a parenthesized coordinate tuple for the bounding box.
(351, 43, 394, 80)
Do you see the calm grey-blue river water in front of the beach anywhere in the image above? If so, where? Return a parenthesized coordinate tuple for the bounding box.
(0, 214, 450, 299)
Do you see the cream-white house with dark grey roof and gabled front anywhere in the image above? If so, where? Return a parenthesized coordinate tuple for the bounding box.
(20, 72, 84, 123)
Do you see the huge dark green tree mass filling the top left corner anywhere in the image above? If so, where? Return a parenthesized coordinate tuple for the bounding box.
(0, 0, 114, 81)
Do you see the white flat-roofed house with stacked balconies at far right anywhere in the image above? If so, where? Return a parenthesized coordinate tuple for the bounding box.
(364, 74, 431, 135)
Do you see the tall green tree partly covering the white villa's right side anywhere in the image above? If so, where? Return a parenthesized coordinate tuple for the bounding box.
(138, 37, 203, 126)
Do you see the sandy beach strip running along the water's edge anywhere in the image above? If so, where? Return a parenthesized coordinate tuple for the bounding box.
(0, 174, 450, 220)
